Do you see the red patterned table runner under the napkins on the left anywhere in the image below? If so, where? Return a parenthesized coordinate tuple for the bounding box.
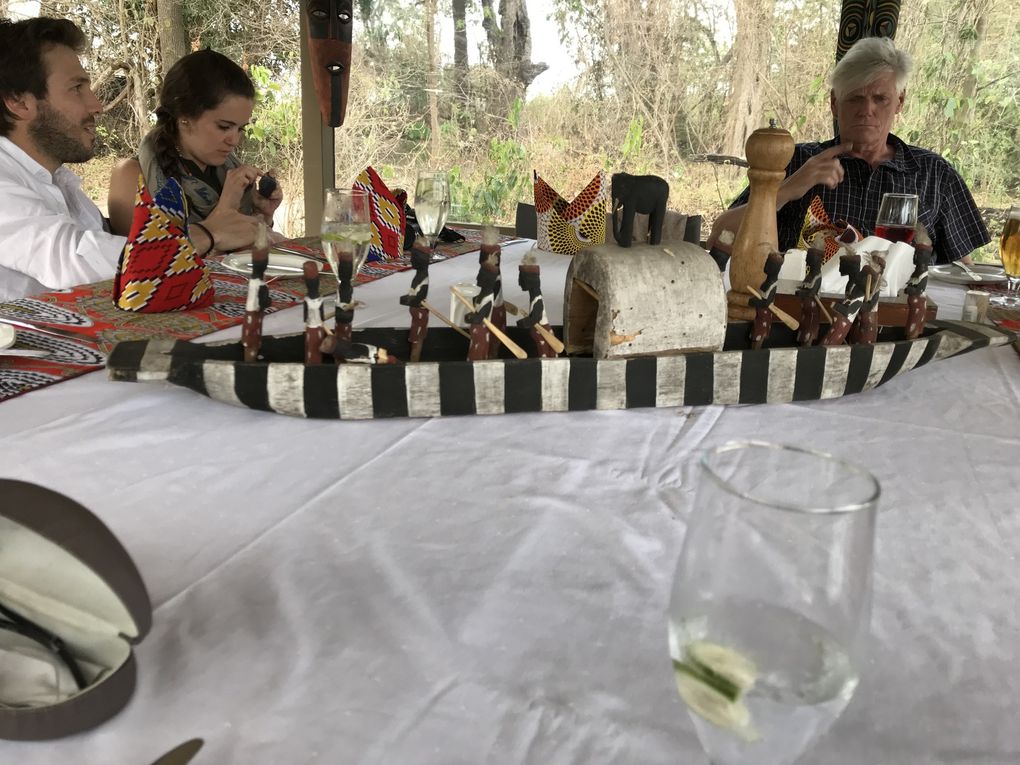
(0, 231, 493, 402)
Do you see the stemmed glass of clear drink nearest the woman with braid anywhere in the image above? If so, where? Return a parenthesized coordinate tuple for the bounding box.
(321, 189, 372, 307)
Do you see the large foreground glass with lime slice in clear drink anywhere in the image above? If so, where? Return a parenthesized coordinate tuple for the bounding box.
(669, 442, 879, 765)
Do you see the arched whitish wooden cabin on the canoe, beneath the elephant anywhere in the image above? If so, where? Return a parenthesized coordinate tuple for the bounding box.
(563, 242, 726, 359)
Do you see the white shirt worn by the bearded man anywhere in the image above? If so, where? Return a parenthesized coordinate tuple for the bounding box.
(0, 136, 125, 300)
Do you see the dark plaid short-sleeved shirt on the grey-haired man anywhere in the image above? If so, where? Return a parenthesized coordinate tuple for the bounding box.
(731, 134, 991, 263)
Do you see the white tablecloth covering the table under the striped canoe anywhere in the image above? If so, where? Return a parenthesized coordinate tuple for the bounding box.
(0, 245, 1020, 765)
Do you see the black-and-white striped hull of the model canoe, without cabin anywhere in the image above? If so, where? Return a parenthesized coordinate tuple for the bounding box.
(107, 321, 1017, 419)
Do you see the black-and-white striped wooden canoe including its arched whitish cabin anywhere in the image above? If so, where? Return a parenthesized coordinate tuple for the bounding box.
(107, 224, 1017, 419)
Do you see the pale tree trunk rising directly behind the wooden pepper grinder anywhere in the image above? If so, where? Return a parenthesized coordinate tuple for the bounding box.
(722, 0, 775, 156)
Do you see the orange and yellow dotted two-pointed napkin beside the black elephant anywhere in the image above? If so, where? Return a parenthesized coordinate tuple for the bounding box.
(534, 170, 609, 255)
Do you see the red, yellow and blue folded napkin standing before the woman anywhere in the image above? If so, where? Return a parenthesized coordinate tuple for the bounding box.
(113, 174, 214, 313)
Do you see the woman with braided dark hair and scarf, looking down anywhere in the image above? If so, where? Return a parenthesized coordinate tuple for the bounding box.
(108, 49, 283, 244)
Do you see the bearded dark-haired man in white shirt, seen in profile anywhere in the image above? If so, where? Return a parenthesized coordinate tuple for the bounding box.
(0, 18, 256, 300)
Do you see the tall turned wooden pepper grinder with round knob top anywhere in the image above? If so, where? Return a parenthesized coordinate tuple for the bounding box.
(726, 119, 794, 321)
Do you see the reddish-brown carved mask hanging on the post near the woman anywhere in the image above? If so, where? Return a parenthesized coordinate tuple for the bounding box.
(305, 0, 354, 128)
